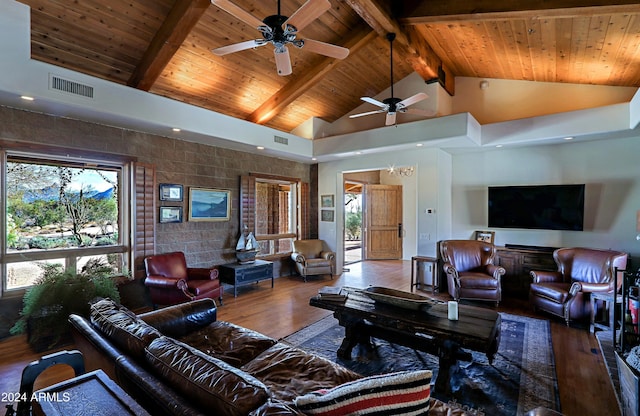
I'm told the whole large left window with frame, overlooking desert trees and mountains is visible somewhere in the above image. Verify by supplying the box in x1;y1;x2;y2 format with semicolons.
1;152;129;293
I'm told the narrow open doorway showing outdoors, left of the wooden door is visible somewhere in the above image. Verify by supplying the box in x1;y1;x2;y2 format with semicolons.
344;181;364;264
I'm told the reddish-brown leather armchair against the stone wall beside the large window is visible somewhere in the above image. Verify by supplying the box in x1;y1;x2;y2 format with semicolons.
144;251;223;307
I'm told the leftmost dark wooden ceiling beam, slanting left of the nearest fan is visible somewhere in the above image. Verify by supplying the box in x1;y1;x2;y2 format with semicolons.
127;0;211;91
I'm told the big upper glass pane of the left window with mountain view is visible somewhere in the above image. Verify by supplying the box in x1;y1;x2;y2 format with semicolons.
6;159;120;253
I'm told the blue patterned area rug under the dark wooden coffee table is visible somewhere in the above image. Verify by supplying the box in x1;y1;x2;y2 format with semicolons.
281;313;560;416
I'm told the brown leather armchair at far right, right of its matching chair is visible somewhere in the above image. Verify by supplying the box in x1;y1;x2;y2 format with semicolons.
529;247;627;325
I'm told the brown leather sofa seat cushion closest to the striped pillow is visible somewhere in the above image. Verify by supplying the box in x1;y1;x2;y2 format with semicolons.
241;343;361;402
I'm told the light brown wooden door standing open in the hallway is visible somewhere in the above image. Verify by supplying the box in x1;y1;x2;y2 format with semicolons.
364;185;402;260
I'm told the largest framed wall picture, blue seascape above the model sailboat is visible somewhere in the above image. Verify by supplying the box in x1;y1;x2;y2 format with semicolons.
189;188;231;221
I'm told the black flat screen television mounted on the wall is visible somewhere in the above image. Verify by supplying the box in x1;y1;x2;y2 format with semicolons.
488;185;585;231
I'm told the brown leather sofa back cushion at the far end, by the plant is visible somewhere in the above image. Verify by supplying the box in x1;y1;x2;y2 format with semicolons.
90;299;162;358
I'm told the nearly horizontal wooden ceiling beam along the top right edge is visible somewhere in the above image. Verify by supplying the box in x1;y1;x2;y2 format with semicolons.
398;0;640;25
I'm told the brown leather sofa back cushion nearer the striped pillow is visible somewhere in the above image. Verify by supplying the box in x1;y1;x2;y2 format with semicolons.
146;336;269;416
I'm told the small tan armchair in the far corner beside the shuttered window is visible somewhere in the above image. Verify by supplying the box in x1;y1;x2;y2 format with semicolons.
291;240;336;282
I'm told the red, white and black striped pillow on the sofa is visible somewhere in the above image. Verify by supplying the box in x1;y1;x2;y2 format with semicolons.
295;370;432;416
